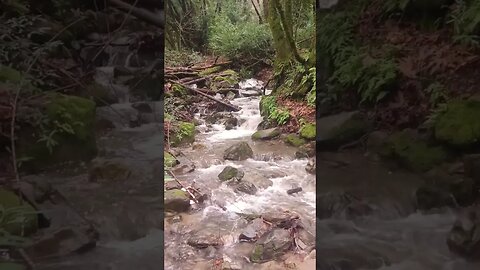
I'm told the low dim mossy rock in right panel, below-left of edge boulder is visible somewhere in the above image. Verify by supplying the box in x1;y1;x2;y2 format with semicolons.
379;130;448;172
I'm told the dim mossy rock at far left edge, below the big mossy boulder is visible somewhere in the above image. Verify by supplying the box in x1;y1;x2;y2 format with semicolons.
0;188;38;236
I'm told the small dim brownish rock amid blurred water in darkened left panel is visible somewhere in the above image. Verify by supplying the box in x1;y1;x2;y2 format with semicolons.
88;158;132;182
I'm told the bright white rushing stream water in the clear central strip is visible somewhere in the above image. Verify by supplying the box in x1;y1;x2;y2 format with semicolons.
165;79;315;270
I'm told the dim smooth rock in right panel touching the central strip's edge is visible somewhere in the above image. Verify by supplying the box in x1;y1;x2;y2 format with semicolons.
317;111;369;151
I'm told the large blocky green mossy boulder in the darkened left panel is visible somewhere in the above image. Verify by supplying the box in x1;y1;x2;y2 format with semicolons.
19;93;97;169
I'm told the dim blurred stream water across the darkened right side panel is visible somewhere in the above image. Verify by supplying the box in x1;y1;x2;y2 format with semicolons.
317;153;480;270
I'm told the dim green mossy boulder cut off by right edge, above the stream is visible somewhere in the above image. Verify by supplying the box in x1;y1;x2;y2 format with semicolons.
434;100;480;148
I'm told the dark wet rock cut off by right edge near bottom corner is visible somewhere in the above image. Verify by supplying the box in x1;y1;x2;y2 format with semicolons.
447;206;480;260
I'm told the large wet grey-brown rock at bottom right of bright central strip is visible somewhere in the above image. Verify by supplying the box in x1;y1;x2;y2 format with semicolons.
250;229;293;263
